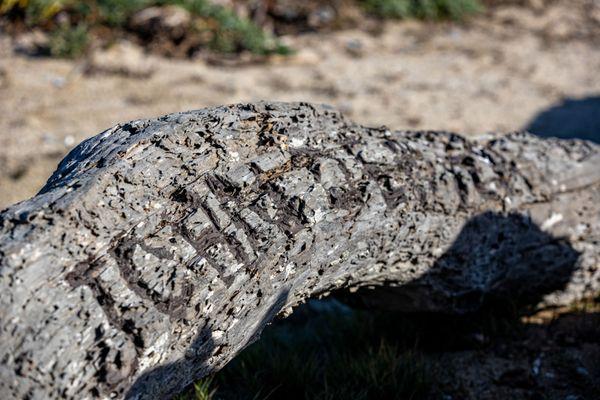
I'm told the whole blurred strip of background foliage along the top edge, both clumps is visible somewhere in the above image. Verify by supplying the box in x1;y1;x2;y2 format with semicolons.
0;0;483;58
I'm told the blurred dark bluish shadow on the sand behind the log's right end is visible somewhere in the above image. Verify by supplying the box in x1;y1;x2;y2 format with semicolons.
524;96;600;143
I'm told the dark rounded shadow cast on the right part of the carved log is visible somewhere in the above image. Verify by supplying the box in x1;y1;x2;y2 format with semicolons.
352;212;579;314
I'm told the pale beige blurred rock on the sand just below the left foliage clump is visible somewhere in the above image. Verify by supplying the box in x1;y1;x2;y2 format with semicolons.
86;41;155;78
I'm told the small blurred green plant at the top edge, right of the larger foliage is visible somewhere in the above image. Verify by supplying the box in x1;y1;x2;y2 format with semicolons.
361;0;483;20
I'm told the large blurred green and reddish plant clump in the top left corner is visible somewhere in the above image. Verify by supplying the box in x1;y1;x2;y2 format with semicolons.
0;0;291;57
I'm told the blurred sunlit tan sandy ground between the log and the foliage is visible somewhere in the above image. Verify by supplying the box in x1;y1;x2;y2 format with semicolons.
0;0;600;208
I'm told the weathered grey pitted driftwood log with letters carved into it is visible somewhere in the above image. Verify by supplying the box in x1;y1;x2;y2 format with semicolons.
0;103;600;399
